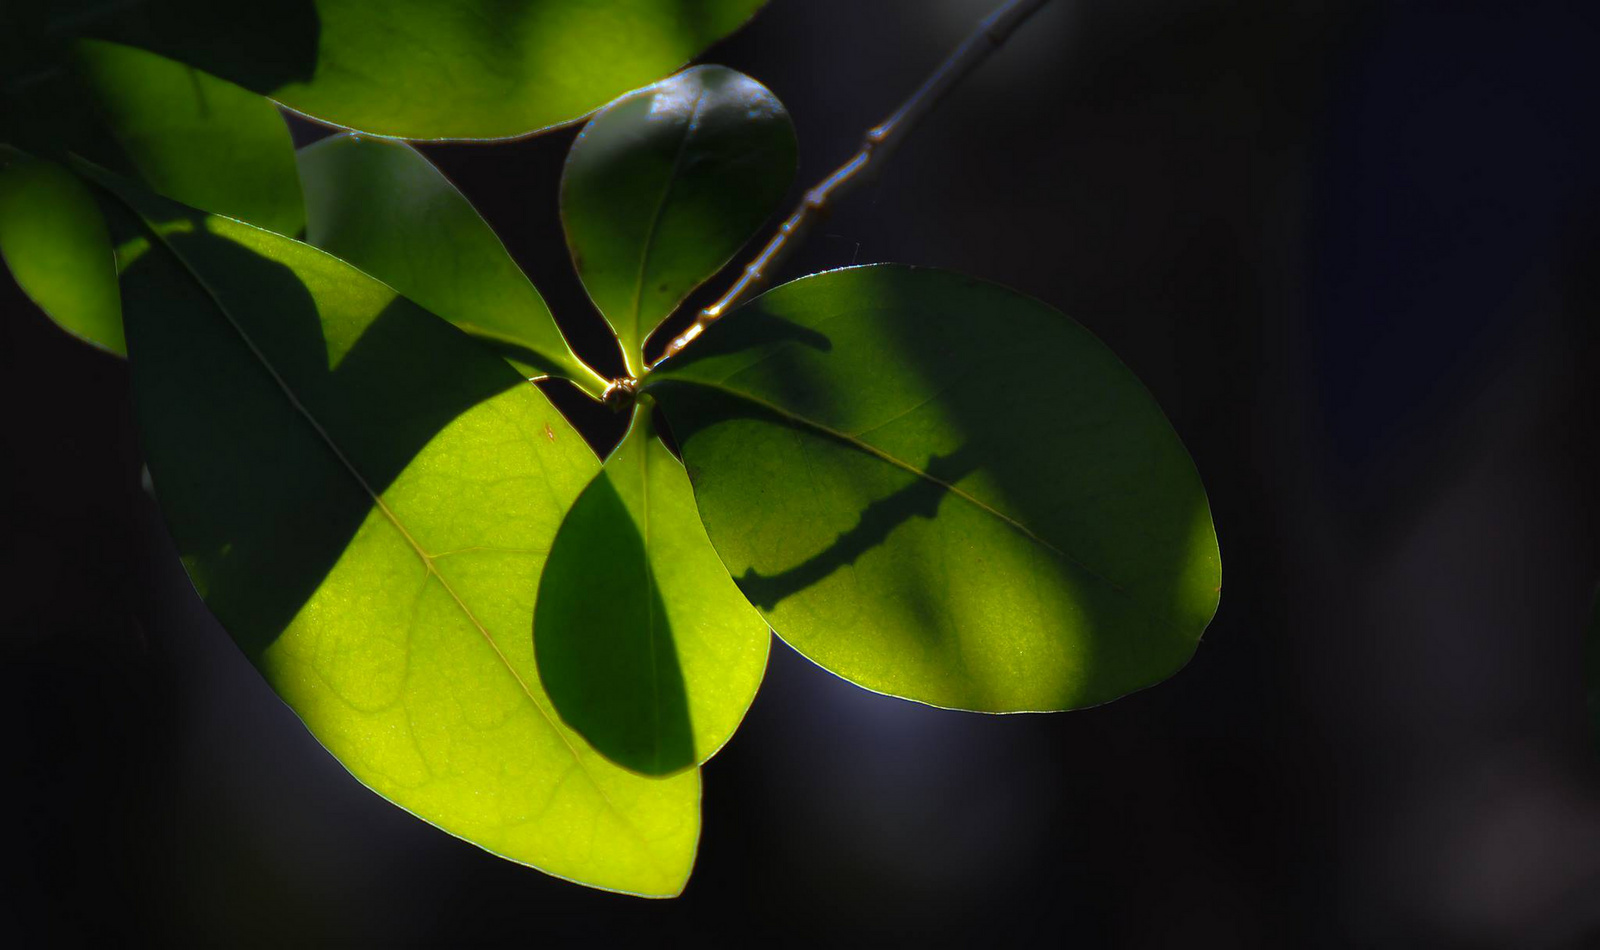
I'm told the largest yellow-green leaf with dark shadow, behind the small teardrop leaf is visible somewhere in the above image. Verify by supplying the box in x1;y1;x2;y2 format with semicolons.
96;171;699;896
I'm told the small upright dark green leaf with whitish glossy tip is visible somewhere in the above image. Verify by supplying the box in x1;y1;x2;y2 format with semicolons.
562;66;795;369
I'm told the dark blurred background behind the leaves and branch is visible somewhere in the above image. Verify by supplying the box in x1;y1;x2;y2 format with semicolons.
0;0;1600;947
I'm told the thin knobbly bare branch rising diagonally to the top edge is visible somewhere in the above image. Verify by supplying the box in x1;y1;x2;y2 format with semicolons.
656;0;1050;363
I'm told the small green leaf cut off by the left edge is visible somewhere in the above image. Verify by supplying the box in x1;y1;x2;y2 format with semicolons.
0;152;126;357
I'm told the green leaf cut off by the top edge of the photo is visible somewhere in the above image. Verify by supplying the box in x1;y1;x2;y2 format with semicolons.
48;0;763;139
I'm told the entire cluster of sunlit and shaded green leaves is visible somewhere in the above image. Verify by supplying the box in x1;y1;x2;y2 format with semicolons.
0;0;1219;896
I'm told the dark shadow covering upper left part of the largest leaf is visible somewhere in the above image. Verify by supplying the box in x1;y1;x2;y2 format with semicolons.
112;203;533;662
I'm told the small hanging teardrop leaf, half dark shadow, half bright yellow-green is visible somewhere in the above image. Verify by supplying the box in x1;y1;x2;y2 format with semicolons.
533;406;771;774
